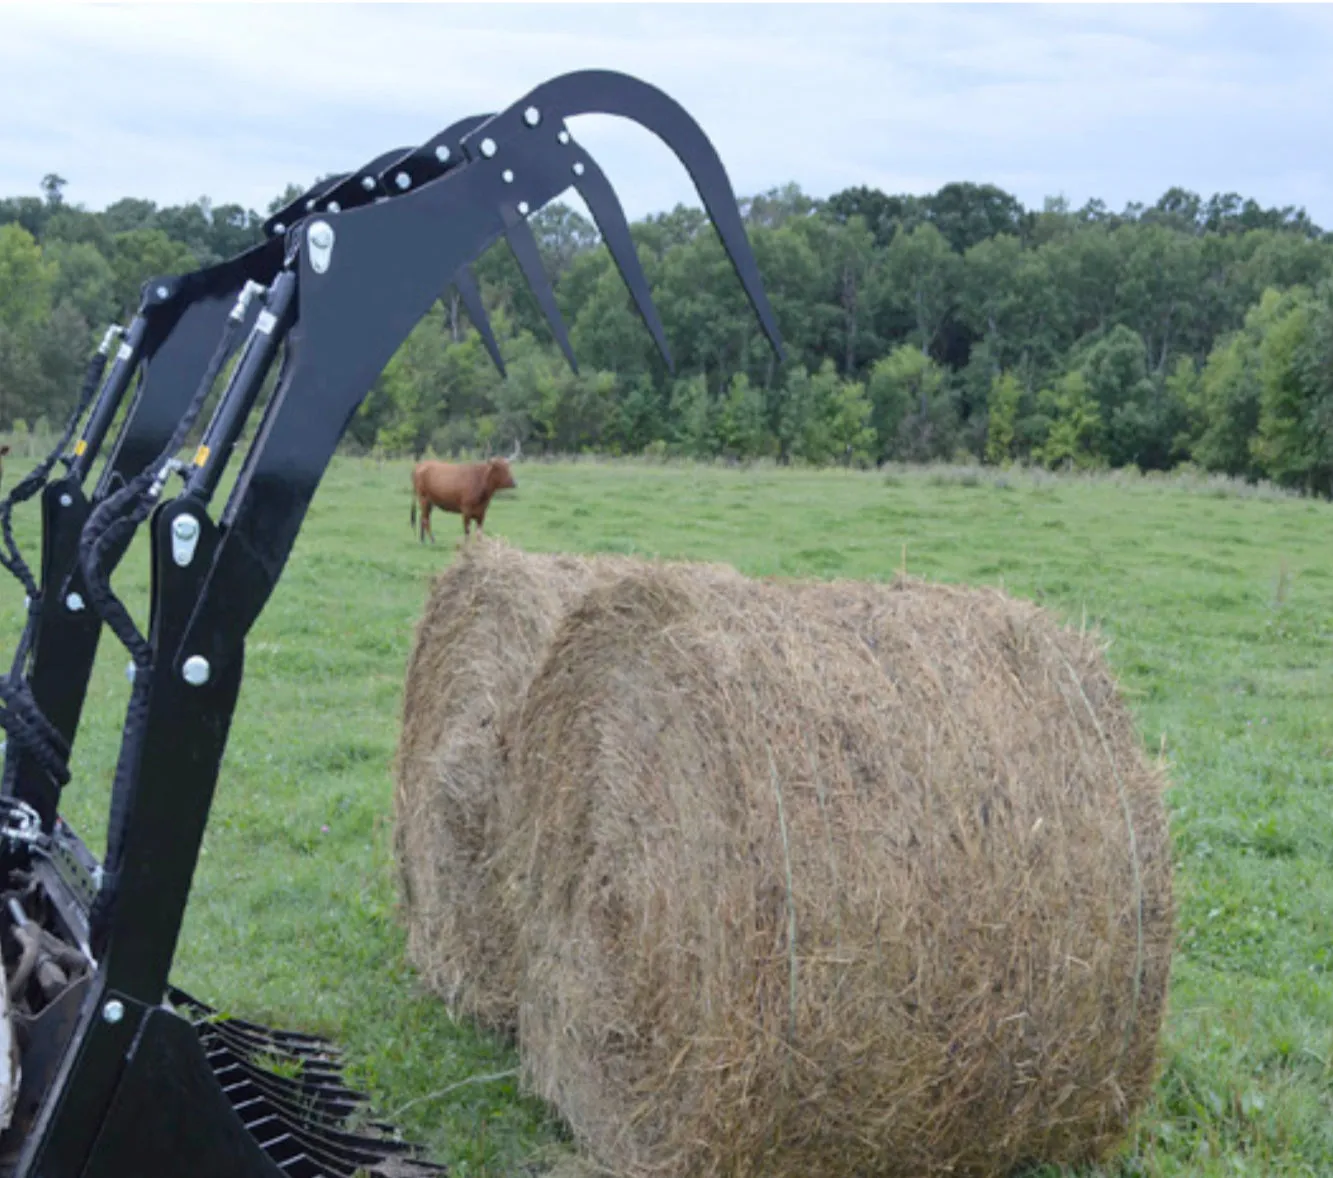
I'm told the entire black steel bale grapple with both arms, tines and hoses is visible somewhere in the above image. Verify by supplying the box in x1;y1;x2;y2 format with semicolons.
0;71;781;1178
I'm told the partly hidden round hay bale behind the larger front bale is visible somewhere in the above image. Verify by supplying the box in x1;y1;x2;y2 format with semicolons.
393;538;629;1030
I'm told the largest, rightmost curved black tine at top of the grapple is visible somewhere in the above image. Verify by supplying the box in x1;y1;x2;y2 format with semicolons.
463;69;785;360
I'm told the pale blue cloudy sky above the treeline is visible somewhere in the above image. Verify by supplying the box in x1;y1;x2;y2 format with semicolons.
0;0;1333;228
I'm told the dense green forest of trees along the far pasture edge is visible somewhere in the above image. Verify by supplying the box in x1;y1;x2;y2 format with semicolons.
0;175;1333;496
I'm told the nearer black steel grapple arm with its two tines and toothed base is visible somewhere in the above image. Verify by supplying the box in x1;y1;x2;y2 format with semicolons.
0;72;781;1178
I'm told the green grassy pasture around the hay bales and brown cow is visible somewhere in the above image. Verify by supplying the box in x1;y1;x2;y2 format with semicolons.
0;458;1333;1178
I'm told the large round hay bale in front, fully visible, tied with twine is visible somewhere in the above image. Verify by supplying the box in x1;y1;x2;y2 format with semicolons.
499;569;1172;1178
